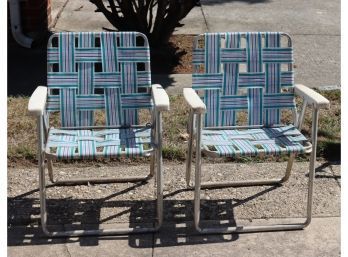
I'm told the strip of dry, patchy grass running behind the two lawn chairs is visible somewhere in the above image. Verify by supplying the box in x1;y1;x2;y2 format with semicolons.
7;90;341;166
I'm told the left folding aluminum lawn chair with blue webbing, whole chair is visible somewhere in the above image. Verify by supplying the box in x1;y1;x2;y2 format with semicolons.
28;32;169;236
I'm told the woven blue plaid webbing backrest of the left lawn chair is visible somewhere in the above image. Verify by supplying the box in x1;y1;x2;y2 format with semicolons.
47;32;152;127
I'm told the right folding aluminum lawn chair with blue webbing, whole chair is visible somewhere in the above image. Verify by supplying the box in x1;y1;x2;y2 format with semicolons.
184;32;329;233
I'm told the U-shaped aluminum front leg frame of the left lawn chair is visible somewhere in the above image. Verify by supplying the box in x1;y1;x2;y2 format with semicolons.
37;110;163;237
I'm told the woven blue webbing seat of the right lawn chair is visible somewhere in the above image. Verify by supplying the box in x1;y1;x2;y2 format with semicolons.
202;125;311;157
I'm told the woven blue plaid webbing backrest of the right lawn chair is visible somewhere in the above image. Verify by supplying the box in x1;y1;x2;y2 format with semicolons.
192;32;295;127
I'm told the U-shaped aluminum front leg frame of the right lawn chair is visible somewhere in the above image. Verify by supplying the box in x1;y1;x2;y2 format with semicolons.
194;109;319;234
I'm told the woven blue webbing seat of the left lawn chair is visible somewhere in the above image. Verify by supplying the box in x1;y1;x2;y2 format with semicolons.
46;127;154;160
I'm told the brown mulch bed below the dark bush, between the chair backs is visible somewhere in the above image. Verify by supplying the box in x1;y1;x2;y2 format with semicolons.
151;35;194;74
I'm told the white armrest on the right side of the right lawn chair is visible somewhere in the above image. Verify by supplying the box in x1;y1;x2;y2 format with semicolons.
295;84;330;109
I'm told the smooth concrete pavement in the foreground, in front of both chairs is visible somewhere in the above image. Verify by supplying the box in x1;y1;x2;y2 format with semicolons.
7;217;340;257
